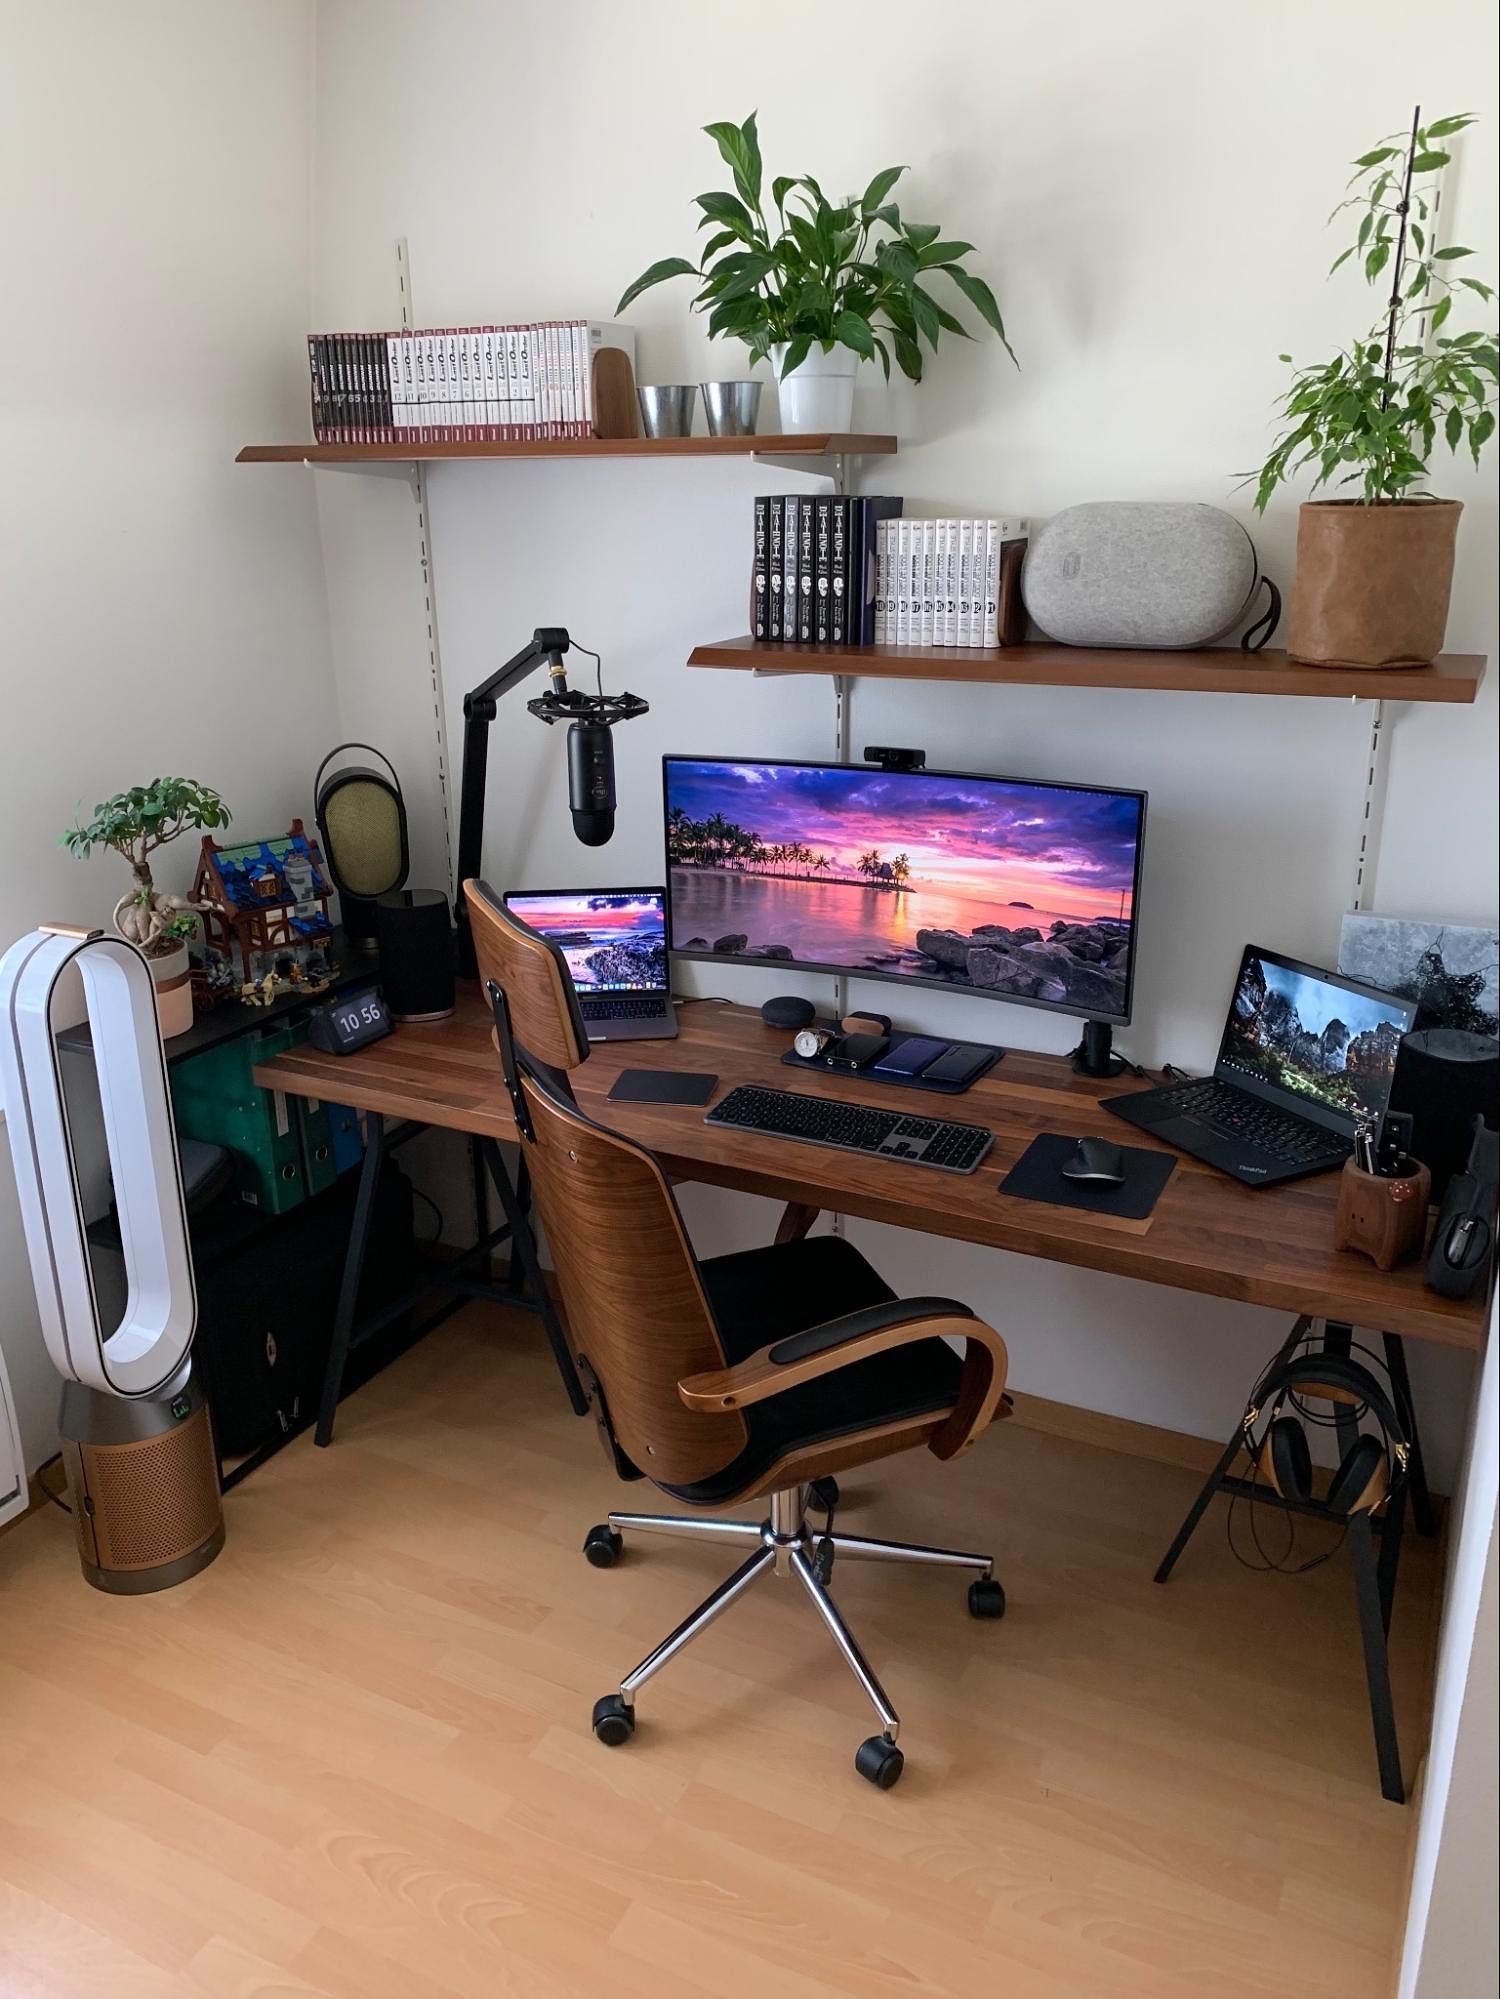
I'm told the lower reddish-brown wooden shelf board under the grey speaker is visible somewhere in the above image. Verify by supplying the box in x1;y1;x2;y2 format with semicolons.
688;636;1486;704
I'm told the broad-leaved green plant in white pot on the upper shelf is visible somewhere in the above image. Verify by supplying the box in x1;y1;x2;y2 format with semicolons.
616;112;1016;432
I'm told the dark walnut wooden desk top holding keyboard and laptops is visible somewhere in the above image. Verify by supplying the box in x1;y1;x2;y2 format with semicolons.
254;992;1486;1351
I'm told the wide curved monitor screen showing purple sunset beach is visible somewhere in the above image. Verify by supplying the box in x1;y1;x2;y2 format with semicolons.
662;756;1146;1021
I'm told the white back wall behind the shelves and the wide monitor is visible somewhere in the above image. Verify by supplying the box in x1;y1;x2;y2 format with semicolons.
312;0;1498;1477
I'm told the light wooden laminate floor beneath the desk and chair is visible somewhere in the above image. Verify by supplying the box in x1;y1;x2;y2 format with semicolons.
0;1305;1436;1999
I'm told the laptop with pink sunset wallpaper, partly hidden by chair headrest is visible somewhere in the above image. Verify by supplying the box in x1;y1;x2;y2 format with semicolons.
506;888;678;1041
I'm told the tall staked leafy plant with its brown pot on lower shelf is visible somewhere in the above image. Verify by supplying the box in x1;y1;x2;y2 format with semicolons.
1256;110;1500;666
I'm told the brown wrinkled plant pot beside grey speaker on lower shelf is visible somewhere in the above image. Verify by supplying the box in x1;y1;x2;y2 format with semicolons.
1286;500;1464;666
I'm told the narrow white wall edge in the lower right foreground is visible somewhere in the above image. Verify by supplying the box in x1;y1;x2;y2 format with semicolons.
1398;1313;1500;1999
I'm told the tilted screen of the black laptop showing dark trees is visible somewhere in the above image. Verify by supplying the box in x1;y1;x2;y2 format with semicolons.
1214;944;1416;1133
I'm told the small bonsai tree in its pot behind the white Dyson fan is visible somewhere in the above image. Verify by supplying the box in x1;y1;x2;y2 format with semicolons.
62;778;230;1039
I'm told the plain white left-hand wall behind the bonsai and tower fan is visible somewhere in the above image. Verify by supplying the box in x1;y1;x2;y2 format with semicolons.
0;0;334;1465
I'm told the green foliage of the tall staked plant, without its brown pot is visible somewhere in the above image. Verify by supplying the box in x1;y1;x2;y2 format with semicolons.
1256;108;1500;512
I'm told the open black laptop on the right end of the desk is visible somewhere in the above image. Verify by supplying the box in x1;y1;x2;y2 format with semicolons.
1106;944;1416;1187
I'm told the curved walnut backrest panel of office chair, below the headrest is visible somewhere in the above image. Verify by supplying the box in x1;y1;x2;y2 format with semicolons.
496;1015;746;1485
